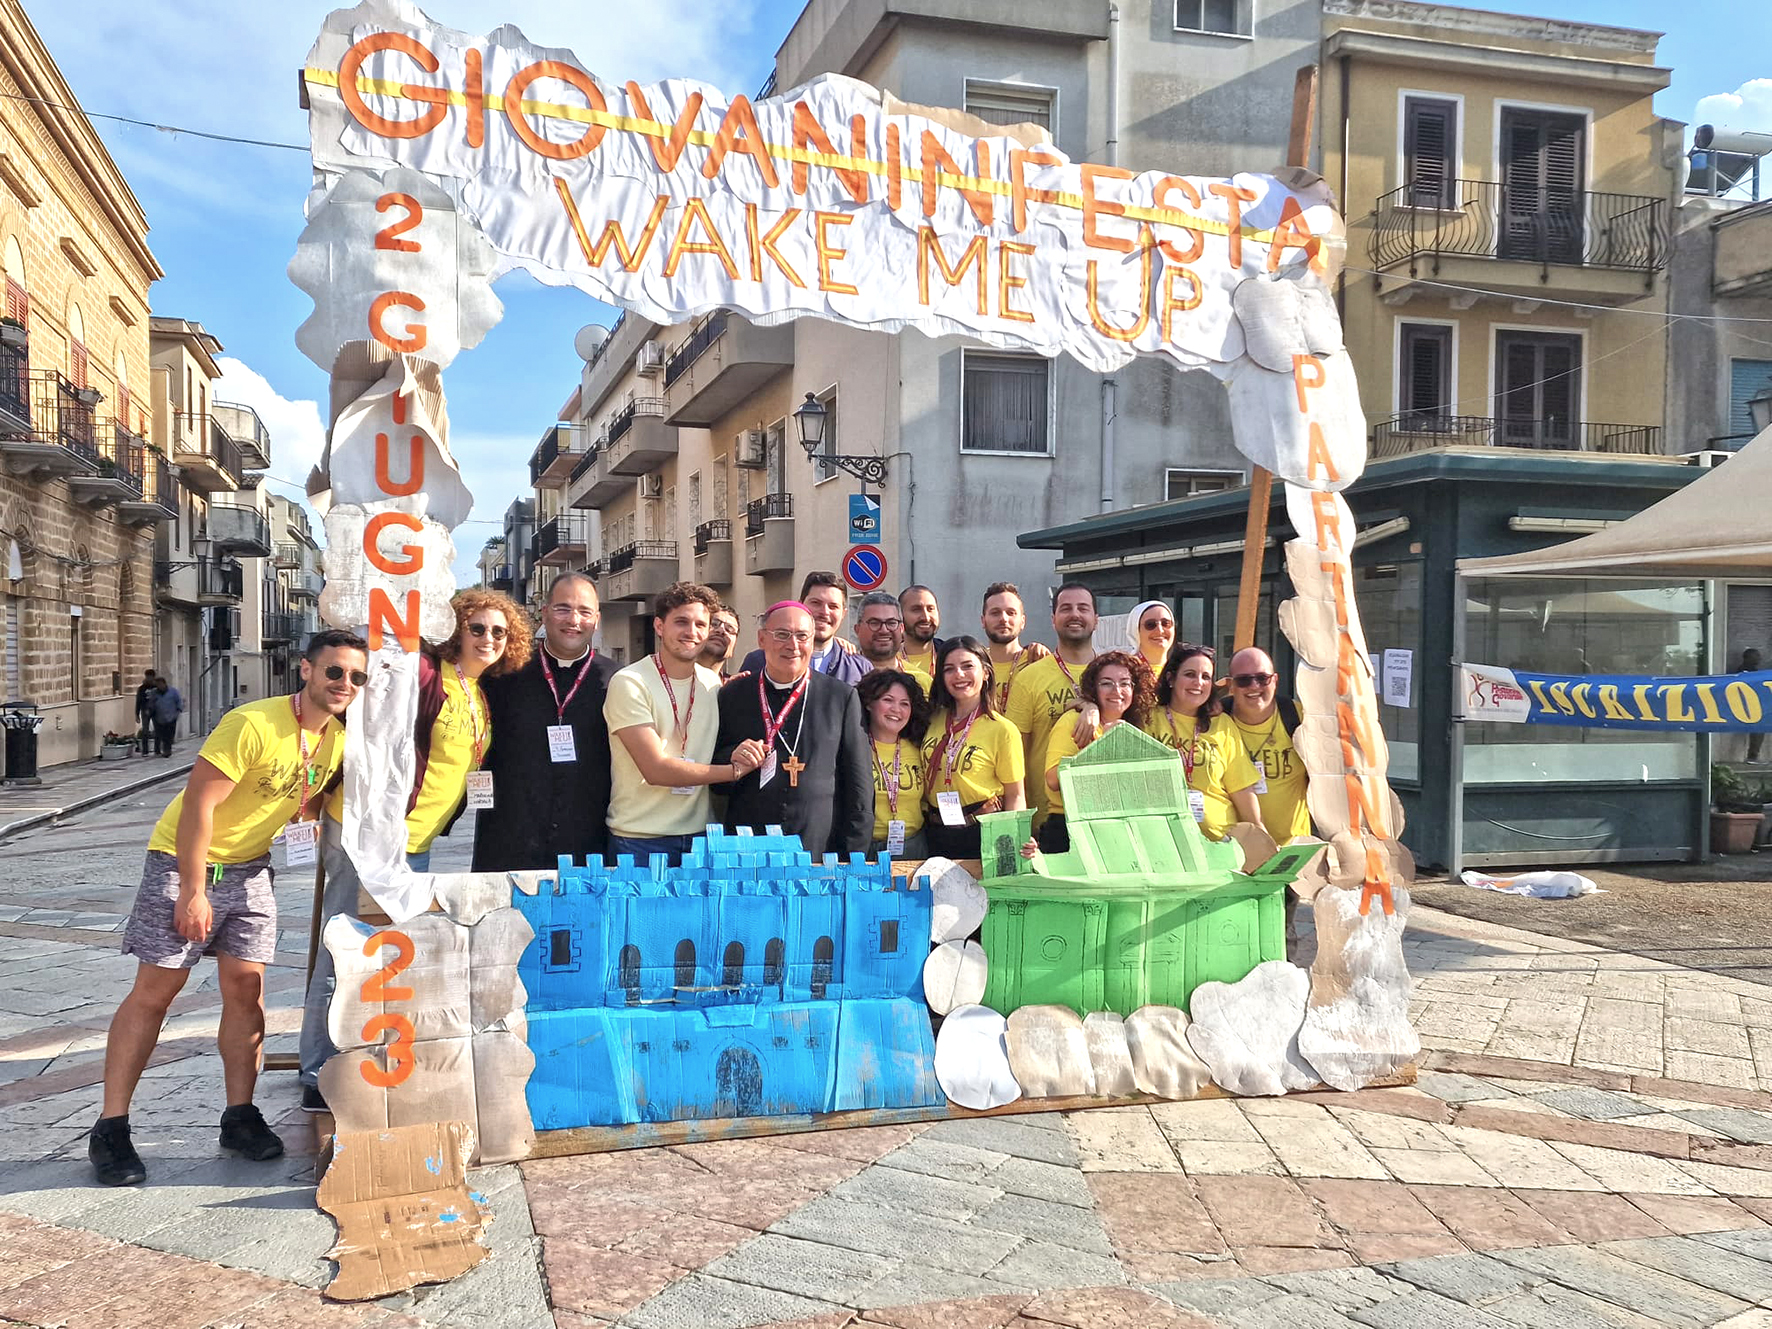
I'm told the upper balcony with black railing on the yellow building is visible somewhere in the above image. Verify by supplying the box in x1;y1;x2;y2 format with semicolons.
1372;177;1667;303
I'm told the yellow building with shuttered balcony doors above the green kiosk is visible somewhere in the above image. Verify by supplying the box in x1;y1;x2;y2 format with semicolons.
1320;0;1682;461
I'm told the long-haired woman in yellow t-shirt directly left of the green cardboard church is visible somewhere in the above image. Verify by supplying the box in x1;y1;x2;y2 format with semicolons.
923;636;1028;858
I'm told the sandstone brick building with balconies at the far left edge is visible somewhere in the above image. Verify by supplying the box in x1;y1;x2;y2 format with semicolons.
0;4;171;766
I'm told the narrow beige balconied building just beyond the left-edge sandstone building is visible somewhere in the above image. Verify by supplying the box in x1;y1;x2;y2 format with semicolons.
149;315;272;734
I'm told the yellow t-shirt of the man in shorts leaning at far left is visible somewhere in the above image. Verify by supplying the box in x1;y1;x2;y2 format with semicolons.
147;696;344;865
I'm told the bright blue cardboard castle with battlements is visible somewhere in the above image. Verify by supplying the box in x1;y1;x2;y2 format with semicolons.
512;826;943;1131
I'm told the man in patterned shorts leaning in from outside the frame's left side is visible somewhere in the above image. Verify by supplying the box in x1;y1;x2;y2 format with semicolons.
87;631;369;1185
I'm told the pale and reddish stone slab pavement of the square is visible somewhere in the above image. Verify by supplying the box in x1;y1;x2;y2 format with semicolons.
10;789;1772;1329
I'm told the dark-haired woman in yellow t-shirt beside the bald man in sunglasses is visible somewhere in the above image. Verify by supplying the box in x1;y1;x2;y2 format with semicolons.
1145;643;1262;840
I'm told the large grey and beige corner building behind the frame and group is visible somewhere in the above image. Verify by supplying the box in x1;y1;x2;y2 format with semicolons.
524;0;1320;659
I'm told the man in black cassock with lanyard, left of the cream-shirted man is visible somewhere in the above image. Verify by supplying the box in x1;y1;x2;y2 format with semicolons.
473;572;617;872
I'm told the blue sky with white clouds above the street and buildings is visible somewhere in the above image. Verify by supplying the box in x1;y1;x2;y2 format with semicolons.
25;0;1772;572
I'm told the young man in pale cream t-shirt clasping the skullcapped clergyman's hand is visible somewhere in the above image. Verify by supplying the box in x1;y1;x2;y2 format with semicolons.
602;581;764;863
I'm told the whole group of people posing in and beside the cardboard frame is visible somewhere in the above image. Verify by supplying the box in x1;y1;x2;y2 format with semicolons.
89;572;1310;1185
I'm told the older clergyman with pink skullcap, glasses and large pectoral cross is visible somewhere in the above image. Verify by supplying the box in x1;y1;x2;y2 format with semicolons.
714;601;874;858
